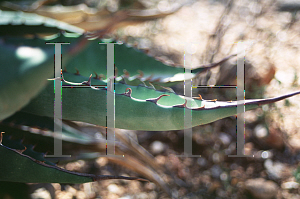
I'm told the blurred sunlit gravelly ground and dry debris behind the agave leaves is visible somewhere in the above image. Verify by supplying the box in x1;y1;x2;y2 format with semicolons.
0;0;300;199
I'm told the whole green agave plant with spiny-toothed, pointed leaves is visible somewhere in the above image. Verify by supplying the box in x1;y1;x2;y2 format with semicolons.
0;6;300;197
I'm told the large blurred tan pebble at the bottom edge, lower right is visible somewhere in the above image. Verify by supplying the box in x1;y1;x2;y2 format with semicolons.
245;178;279;199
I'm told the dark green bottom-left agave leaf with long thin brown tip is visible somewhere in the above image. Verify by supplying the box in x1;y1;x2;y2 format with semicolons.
0;133;147;184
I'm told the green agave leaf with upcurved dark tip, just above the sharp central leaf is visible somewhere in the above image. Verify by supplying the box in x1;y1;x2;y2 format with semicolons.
65;37;235;86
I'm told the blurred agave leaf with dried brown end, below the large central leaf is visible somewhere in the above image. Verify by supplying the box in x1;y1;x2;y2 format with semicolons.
0;112;170;193
